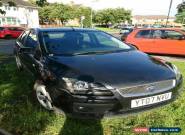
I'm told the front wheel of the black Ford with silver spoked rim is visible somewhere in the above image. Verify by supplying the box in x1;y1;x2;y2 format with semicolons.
34;80;54;111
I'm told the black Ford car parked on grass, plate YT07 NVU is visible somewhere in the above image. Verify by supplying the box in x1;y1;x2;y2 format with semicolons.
14;28;183;118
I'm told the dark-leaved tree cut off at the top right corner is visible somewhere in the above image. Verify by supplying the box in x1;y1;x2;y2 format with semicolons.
176;2;185;23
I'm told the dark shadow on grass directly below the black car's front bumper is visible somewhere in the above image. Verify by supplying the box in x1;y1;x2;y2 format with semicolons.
59;117;103;135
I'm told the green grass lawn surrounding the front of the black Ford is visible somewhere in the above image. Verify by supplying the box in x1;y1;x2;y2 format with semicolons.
0;56;185;135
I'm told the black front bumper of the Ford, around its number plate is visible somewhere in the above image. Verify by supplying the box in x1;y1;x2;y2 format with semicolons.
55;77;183;118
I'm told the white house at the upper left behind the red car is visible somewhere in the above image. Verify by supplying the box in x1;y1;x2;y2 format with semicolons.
0;0;39;27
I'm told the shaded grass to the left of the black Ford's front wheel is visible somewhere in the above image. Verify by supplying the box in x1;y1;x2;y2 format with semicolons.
0;55;56;135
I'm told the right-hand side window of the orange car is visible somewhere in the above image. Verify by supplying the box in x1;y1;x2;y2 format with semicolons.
163;30;183;40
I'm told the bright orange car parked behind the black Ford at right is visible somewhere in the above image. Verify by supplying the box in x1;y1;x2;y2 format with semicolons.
125;28;185;56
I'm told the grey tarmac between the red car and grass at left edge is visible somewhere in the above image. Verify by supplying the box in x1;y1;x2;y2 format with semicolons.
0;39;15;54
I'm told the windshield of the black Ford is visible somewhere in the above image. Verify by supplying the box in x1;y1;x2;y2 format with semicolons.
42;31;131;55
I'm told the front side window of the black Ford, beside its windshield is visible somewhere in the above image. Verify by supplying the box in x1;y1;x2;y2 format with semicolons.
25;30;37;48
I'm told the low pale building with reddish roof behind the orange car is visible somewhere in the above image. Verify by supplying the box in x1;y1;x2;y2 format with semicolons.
132;15;179;25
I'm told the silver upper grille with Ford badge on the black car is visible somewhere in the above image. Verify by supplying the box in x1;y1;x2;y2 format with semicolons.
119;80;176;97
